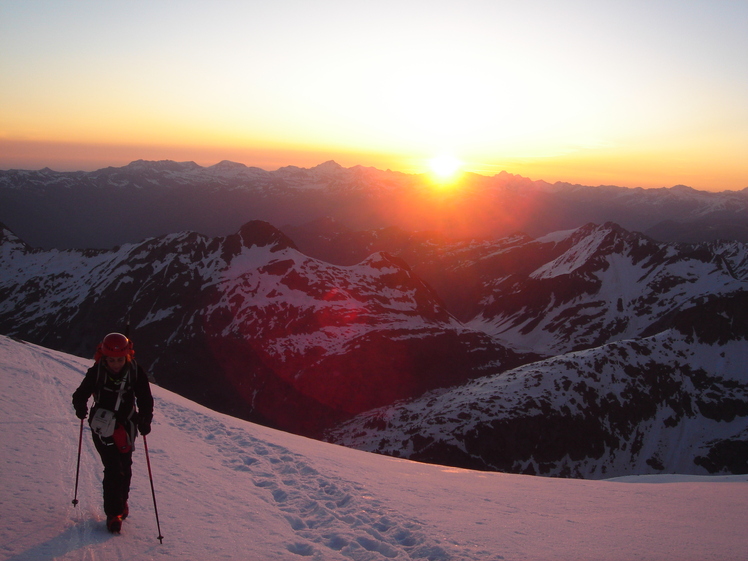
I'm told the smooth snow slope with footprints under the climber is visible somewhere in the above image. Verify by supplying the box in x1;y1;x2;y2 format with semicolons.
0;336;748;561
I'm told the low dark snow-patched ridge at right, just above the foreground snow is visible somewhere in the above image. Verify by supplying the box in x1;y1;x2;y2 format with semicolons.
327;316;748;478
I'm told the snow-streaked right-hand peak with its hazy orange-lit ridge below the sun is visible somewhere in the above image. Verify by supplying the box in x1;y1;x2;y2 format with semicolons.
286;221;748;334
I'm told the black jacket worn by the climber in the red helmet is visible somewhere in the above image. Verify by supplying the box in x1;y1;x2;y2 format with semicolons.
73;360;153;438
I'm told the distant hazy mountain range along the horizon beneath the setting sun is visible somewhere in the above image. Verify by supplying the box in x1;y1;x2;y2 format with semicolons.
0;160;748;247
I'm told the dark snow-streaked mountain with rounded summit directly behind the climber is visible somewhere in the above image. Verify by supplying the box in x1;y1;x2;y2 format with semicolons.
0;222;537;435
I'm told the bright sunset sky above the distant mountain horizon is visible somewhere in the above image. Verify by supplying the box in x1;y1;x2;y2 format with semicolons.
0;0;748;191
